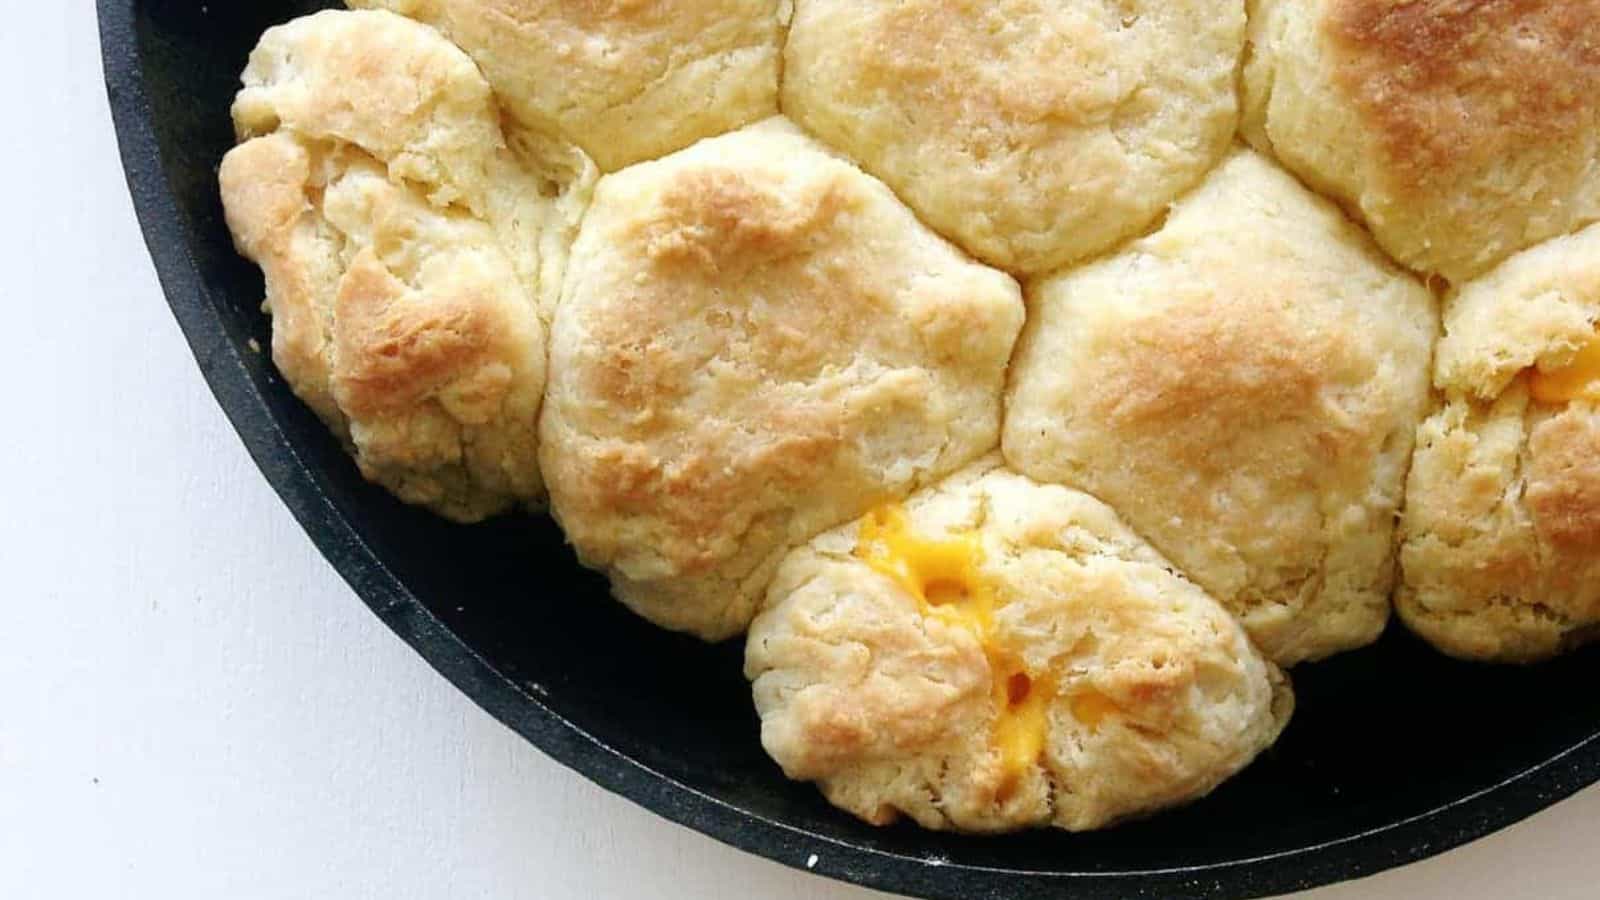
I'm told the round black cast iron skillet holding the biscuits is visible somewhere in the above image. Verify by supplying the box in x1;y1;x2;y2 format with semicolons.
98;0;1600;900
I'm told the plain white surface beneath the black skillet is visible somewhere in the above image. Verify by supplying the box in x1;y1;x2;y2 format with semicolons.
0;7;1600;900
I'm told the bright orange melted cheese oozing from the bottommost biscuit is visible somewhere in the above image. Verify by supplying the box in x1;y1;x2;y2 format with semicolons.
856;506;1056;786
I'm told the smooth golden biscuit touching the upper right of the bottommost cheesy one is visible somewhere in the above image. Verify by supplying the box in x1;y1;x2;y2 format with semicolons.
1003;151;1438;665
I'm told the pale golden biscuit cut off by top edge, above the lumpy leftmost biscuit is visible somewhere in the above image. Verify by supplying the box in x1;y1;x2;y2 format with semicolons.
349;0;782;171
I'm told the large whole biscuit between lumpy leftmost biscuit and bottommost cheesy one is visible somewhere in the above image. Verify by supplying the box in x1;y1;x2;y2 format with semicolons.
541;119;1022;639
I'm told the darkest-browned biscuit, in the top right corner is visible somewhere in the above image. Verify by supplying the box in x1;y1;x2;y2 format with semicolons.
1245;0;1600;282
